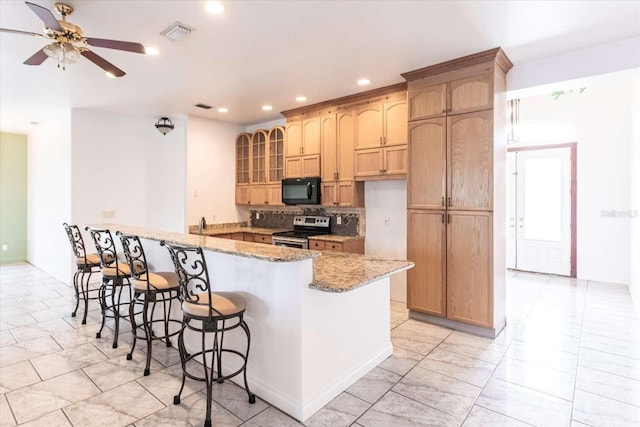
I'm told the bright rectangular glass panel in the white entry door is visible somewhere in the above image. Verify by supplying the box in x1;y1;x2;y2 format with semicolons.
524;158;562;242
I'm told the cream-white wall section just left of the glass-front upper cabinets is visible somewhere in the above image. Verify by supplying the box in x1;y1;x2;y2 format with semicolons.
187;116;248;225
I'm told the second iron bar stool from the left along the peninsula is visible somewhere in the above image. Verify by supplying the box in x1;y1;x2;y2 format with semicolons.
85;227;141;348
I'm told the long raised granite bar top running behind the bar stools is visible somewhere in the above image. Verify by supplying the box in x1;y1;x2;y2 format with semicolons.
90;224;320;262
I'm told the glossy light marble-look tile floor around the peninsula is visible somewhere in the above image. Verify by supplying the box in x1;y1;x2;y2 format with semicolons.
0;264;640;427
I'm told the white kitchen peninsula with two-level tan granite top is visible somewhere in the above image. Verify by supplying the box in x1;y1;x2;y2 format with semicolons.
92;224;413;421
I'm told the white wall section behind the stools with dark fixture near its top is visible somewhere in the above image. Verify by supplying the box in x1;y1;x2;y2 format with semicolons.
71;109;186;232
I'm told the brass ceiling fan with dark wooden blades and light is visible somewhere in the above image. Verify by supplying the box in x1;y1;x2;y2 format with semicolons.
0;2;145;77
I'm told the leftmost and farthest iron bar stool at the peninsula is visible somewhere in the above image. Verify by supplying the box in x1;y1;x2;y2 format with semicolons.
62;226;100;325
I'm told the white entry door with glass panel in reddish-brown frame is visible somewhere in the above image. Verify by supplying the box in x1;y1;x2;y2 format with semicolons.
507;142;577;277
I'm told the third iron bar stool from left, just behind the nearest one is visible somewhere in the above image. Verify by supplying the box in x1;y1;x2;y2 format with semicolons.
116;231;182;376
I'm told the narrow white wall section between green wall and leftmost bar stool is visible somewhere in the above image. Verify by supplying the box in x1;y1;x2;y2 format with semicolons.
27;110;72;283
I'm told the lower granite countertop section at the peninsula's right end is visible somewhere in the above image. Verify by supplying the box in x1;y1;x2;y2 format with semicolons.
309;251;415;292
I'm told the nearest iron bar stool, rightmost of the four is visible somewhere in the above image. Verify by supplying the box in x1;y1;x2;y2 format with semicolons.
160;241;256;427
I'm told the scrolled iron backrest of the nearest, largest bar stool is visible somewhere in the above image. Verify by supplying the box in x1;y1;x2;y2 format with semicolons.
160;241;222;317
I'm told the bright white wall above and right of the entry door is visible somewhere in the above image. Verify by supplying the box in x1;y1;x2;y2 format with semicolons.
520;80;632;283
